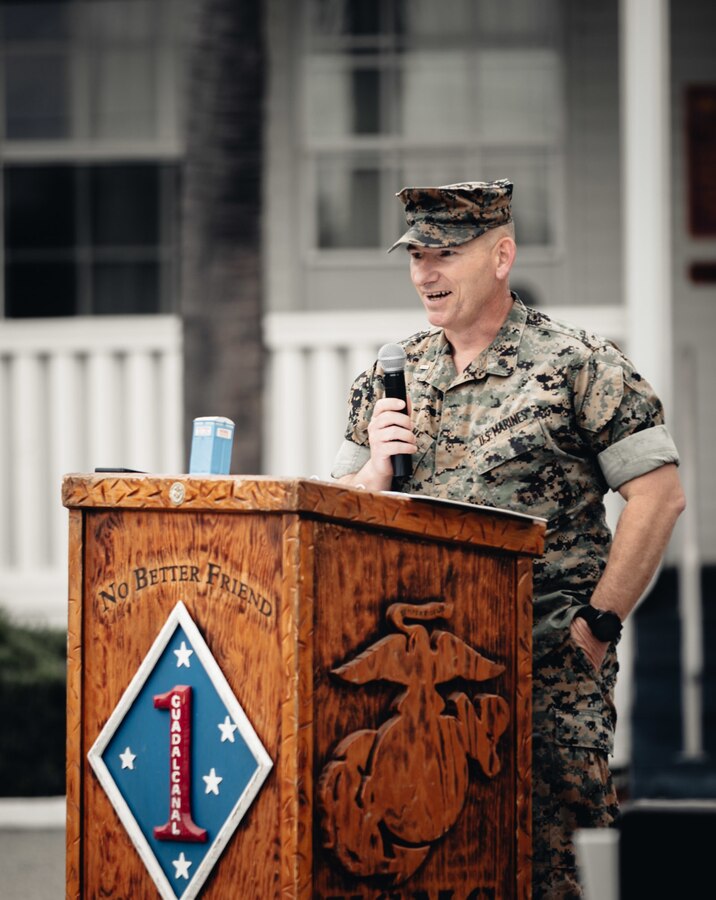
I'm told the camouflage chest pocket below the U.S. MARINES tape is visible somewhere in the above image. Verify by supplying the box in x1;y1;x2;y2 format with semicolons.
473;422;573;519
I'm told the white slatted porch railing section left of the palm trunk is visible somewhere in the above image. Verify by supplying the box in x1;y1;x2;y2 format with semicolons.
0;316;185;625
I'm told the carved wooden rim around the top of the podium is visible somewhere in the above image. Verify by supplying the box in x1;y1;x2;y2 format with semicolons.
62;473;546;556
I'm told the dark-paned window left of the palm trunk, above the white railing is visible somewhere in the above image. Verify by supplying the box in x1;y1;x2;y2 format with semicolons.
0;0;184;318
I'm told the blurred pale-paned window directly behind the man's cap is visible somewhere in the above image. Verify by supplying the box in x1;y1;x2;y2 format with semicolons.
300;0;564;261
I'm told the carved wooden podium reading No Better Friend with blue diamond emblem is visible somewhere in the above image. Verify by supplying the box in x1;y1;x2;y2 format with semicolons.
63;474;544;900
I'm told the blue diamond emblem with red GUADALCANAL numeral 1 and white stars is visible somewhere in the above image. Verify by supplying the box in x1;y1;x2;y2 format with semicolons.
88;603;273;900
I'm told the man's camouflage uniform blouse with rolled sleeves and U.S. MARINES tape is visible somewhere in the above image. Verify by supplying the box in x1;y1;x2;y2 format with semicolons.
332;295;678;659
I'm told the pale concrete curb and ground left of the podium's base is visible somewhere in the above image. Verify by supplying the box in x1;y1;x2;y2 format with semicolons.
0;797;65;900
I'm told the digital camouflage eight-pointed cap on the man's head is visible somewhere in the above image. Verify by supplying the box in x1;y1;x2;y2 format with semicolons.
388;178;512;253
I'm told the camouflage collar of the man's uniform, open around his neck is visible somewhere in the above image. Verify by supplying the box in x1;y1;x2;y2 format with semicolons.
417;291;527;391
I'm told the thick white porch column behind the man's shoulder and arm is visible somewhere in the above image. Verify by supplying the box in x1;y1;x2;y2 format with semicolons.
615;0;673;764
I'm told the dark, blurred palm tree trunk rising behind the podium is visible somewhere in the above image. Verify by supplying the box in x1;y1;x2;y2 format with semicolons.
181;0;266;474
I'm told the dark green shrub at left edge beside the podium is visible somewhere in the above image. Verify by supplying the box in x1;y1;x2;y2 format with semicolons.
0;610;67;797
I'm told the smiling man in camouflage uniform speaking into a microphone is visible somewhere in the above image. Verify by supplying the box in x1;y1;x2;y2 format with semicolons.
333;180;684;900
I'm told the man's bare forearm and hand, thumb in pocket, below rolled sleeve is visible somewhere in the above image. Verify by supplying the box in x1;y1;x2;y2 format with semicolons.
571;464;686;669
